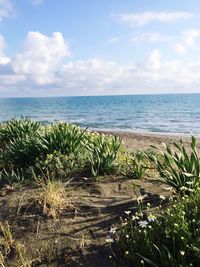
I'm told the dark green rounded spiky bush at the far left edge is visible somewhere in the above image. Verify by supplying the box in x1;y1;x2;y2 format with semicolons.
0;119;43;168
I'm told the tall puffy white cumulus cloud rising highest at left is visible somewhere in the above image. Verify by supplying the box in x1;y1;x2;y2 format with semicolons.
12;32;70;84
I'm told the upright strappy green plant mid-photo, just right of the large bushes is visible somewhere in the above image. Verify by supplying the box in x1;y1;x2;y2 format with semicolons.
88;134;121;177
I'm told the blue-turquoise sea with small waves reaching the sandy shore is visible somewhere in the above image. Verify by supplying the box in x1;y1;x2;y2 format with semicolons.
0;94;200;135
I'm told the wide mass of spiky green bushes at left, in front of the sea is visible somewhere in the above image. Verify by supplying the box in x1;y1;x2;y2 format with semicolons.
0;119;87;172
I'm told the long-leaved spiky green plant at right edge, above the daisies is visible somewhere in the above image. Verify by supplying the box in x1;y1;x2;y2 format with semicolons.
149;136;200;195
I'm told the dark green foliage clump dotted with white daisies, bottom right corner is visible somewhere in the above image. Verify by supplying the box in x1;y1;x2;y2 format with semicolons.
108;189;200;267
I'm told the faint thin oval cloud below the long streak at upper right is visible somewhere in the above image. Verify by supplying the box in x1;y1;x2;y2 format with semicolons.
131;32;172;45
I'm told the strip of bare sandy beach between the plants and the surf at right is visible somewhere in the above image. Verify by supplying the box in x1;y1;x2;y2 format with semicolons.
98;131;197;150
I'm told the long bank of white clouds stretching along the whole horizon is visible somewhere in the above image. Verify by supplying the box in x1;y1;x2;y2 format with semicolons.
0;32;200;96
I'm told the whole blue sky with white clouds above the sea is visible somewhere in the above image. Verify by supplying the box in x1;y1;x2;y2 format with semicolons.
0;0;200;97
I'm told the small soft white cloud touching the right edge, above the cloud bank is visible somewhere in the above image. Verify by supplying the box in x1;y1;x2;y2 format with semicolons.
175;29;200;54
